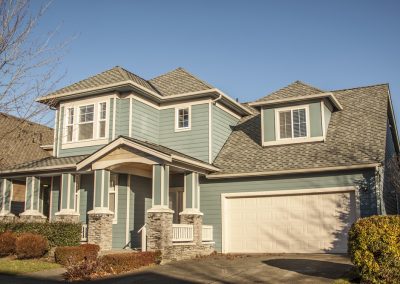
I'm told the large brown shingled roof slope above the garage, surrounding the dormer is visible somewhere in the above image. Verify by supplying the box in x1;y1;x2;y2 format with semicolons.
214;82;389;175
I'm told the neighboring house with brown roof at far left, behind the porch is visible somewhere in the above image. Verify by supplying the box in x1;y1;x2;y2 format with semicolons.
0;113;54;215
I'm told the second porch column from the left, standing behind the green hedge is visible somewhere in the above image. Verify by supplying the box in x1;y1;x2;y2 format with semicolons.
19;176;47;222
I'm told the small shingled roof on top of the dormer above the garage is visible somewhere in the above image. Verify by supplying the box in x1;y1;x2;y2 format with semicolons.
255;81;325;102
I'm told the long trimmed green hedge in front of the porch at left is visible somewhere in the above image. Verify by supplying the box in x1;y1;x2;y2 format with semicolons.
0;222;82;247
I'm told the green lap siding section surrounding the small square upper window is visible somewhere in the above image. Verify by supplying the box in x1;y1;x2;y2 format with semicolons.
159;104;209;162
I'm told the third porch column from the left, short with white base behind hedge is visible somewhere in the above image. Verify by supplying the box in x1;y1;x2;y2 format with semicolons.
54;173;79;223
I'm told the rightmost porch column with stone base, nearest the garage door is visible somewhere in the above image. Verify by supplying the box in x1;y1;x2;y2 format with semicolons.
179;172;203;245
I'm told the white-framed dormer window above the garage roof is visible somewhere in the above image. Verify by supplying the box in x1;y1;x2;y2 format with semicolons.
278;108;308;139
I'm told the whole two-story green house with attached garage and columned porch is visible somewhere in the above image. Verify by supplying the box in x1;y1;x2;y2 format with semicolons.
0;66;399;258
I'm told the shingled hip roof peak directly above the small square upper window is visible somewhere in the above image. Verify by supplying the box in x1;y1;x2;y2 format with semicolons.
149;67;214;96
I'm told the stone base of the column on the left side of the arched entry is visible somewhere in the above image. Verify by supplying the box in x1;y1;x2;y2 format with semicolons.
88;209;114;251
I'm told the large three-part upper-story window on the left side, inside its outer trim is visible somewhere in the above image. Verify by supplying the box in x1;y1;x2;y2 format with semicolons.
64;102;108;142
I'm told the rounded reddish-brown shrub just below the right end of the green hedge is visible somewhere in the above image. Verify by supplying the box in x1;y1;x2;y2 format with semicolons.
54;244;100;265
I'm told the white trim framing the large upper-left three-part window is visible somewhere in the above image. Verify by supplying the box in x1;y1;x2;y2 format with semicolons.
62;98;110;145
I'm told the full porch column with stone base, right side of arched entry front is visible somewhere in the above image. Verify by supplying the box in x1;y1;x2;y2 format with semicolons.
146;165;174;251
